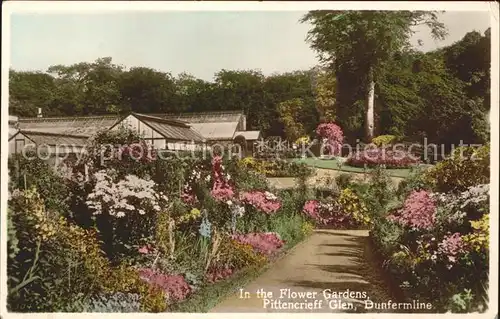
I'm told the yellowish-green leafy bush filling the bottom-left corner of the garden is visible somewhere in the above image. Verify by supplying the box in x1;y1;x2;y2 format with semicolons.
8;189;107;311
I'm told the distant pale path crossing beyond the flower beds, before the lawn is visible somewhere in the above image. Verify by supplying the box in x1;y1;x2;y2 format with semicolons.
267;168;404;189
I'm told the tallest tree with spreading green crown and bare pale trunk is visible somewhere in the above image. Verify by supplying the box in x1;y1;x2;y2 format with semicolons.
301;11;446;141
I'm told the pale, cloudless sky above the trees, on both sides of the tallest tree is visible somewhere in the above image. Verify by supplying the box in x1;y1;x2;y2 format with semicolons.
10;11;490;81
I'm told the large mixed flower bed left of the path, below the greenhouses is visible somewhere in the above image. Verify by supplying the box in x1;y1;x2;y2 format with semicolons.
8;127;310;312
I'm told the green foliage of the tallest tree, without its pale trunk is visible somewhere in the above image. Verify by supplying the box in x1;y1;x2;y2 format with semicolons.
302;10;446;141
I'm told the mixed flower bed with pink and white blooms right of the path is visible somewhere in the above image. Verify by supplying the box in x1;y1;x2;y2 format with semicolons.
371;146;489;312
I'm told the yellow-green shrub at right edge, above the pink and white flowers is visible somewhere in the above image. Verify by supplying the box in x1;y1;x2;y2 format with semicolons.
425;145;490;192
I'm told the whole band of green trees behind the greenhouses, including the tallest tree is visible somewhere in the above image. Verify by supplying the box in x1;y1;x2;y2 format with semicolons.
9;16;491;147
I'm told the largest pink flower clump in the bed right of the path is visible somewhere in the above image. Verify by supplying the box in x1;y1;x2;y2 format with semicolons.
388;190;436;229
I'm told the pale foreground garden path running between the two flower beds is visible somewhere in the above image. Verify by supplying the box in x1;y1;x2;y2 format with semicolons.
210;230;391;313
